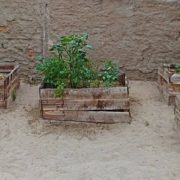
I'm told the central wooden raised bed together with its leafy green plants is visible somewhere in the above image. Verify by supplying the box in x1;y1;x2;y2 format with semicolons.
37;34;131;123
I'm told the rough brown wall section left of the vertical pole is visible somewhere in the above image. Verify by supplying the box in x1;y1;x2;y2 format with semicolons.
0;0;42;77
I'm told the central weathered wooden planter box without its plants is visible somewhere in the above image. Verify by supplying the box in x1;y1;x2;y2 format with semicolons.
39;76;131;123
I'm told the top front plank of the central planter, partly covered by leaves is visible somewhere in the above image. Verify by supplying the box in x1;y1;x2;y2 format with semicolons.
40;87;128;99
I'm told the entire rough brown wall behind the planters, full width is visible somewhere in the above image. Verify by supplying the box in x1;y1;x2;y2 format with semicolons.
0;0;180;79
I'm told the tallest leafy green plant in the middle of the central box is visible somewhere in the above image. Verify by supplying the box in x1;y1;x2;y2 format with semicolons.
48;34;94;88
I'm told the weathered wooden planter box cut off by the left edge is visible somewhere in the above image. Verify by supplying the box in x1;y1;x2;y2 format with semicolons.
0;65;20;108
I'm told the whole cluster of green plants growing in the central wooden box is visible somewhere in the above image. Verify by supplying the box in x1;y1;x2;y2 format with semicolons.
36;34;119;97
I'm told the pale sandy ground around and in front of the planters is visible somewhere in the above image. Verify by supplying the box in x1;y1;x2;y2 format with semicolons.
0;81;180;180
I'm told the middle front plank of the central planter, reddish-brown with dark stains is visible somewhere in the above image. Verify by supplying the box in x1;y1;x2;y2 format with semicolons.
41;98;130;111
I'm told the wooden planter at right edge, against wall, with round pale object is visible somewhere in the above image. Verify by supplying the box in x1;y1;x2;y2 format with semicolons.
158;65;180;105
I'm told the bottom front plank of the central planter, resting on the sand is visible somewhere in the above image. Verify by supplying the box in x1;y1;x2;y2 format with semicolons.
42;111;131;123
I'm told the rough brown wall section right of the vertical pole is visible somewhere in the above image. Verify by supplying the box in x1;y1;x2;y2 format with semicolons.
49;0;180;77
